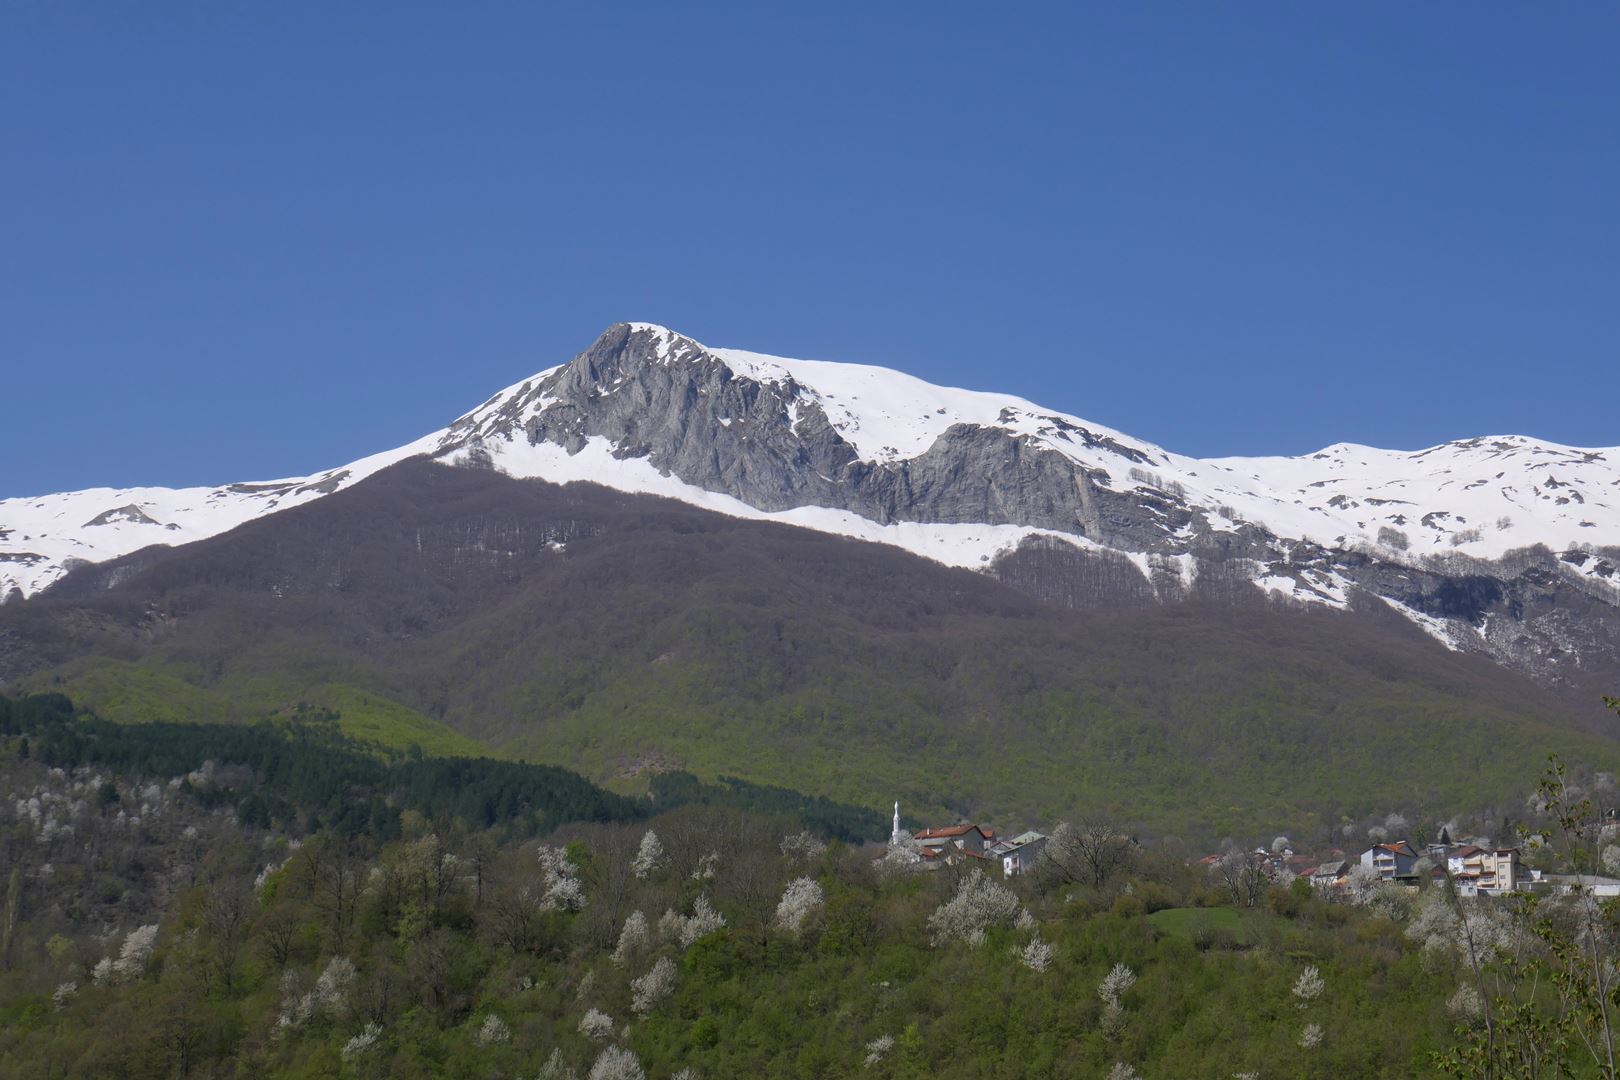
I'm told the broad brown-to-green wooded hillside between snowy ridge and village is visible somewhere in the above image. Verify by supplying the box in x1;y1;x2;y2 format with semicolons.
0;461;1620;834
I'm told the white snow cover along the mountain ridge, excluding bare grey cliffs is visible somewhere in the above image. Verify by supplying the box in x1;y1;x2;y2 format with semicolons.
0;324;1620;604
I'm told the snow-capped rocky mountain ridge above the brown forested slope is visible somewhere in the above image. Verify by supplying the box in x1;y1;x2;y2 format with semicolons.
0;324;1620;680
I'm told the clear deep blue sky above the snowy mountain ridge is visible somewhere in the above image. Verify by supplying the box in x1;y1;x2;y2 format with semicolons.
0;0;1620;495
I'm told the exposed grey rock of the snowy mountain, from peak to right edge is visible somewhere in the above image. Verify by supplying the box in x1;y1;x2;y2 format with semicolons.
441;324;1620;687
